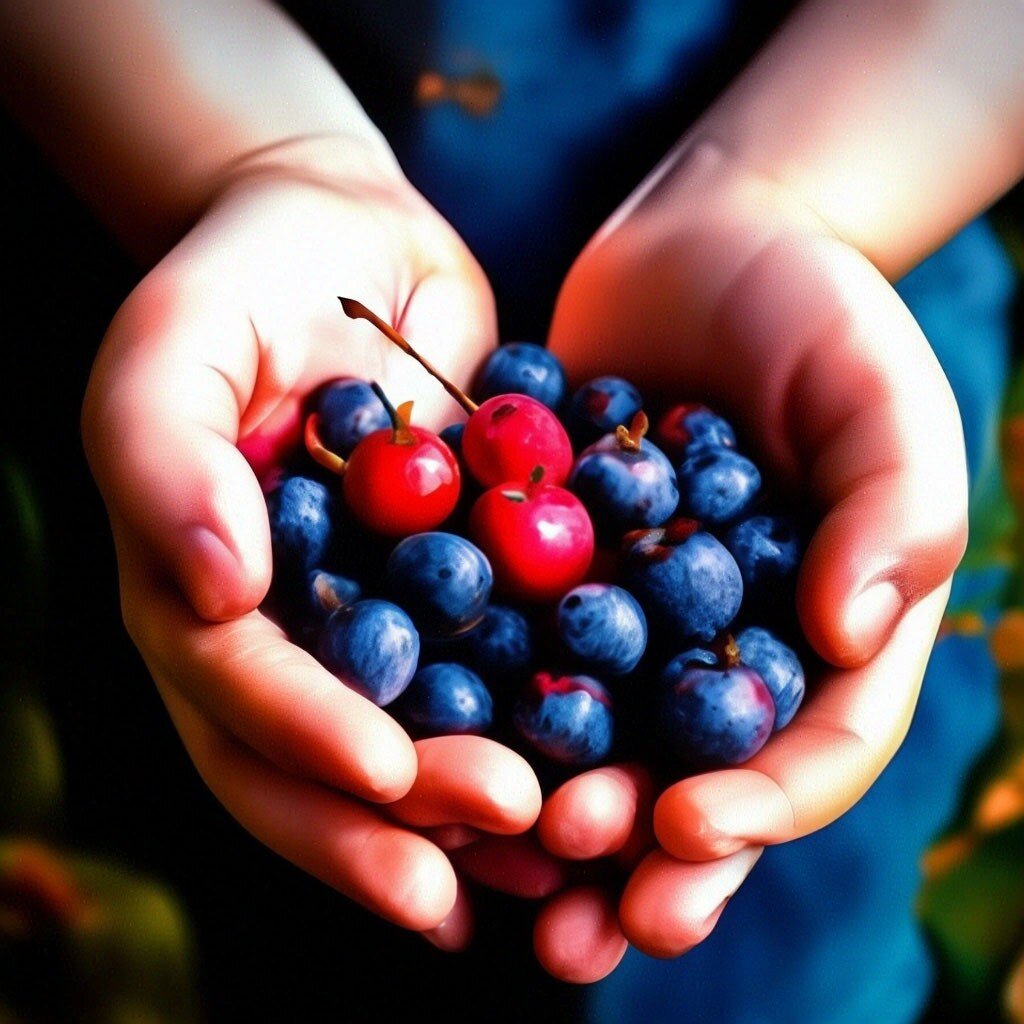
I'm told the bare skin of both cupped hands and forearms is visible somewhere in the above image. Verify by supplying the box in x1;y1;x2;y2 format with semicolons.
0;0;1024;981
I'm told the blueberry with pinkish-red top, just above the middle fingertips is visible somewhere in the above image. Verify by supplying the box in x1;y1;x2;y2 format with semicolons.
513;672;614;765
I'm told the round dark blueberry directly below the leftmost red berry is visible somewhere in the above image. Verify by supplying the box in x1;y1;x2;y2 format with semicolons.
384;532;494;637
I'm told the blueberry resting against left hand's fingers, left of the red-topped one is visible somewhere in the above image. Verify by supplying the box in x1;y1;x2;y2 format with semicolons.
391;662;494;736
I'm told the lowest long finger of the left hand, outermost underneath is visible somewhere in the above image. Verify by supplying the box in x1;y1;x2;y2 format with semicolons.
157;679;457;931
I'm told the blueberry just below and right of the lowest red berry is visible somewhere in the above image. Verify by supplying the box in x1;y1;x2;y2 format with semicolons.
558;583;647;676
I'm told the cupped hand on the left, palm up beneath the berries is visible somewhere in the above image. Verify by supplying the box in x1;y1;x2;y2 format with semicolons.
83;159;540;930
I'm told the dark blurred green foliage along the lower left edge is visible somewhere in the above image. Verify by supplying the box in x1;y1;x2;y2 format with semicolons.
0;454;200;1024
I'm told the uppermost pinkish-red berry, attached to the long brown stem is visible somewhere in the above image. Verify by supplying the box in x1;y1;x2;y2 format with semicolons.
462;394;572;487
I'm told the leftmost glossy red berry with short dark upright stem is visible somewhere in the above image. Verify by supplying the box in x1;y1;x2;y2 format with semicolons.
342;427;460;537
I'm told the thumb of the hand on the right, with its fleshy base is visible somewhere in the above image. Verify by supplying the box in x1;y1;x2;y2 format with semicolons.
722;240;968;667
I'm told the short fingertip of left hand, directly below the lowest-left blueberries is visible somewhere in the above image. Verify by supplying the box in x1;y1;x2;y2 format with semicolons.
388;736;542;836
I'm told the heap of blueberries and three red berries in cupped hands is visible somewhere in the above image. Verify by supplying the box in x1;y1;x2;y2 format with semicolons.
260;300;805;778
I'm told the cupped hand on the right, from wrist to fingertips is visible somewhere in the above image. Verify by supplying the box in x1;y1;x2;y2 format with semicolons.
528;147;967;974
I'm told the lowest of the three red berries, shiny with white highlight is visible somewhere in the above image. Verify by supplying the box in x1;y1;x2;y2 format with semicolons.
469;470;594;601
